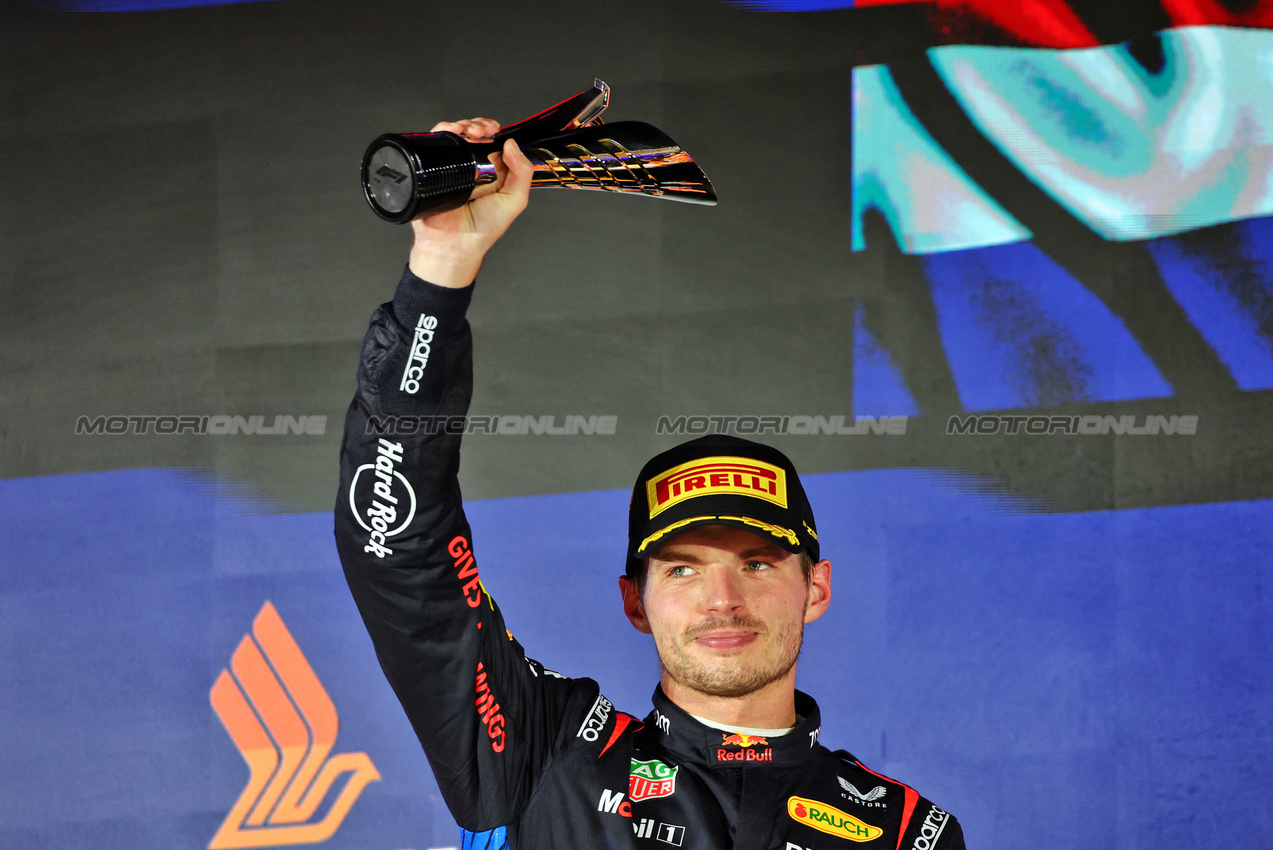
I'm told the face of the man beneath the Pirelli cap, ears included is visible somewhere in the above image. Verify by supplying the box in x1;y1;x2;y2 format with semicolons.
620;526;831;697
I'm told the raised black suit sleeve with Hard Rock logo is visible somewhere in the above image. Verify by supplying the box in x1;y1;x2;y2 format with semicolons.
335;271;597;830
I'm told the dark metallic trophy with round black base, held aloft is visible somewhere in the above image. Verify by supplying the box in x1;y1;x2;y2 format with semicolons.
363;80;717;224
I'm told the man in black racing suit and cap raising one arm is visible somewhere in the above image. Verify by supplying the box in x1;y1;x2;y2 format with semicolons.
336;118;964;850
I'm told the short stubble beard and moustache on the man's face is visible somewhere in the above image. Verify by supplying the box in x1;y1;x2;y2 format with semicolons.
656;617;805;697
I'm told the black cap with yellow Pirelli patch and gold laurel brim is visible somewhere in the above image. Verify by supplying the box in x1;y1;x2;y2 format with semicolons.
628;434;819;575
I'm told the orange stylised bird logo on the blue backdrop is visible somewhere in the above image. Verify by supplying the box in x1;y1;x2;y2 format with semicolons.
207;602;381;850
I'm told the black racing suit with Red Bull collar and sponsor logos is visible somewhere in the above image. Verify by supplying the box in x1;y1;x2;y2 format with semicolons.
336;272;964;850
